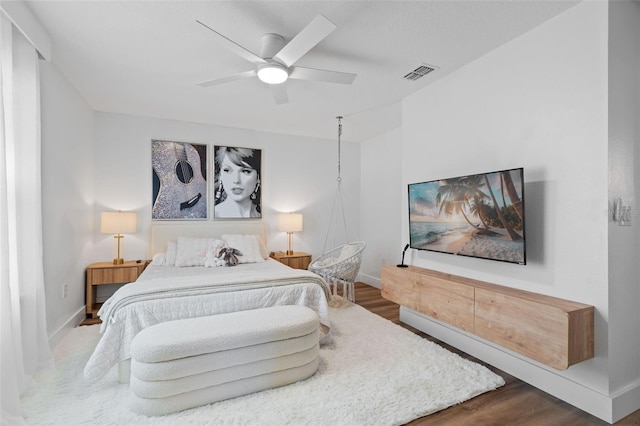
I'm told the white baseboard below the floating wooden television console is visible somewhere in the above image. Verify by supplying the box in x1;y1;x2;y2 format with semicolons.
400;306;640;423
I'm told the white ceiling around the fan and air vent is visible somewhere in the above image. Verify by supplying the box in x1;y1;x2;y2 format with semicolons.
26;0;576;141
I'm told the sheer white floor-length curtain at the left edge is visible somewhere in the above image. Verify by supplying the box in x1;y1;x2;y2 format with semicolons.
0;12;51;425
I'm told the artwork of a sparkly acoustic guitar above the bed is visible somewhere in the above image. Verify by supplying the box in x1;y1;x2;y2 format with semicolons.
151;140;207;220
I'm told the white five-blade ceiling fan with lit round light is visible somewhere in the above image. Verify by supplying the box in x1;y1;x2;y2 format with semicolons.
196;15;356;105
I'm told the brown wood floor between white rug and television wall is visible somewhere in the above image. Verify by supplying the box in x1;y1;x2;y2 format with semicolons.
356;283;640;426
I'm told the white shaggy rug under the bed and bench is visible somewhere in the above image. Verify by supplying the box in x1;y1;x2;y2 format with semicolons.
21;302;504;426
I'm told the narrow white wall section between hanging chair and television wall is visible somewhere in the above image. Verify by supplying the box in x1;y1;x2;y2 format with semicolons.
359;128;408;287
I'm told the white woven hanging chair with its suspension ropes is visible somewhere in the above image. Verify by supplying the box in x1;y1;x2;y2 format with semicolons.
308;116;366;302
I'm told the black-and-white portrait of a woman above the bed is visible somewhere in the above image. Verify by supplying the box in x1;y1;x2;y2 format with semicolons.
213;146;262;219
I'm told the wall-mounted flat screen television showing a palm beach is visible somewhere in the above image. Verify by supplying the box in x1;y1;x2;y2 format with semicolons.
408;168;527;265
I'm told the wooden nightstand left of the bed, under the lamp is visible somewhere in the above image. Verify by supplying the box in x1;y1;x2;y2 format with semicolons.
83;260;149;324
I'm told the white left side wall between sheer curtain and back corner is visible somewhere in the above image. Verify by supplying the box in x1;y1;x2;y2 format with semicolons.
40;61;94;343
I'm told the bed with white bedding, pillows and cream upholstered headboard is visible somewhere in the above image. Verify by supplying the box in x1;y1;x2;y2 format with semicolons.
84;221;331;381
